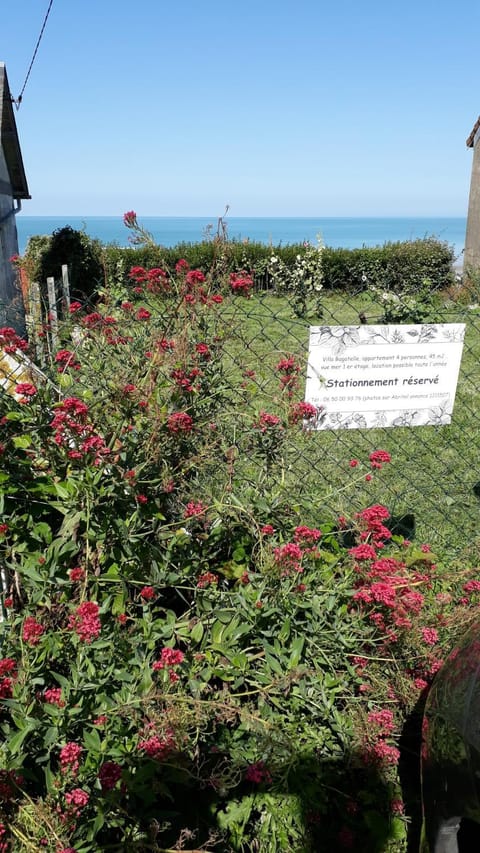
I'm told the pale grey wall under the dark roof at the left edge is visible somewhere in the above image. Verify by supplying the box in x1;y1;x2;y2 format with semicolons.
0;148;24;333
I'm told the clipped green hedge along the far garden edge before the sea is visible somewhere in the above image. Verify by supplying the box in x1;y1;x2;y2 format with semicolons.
22;228;454;302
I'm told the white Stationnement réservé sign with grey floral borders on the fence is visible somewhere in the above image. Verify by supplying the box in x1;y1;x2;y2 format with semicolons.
305;323;465;429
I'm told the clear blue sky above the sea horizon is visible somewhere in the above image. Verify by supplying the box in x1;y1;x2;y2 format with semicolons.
0;0;480;216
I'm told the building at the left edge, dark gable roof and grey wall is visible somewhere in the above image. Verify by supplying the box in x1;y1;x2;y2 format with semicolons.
0;62;30;334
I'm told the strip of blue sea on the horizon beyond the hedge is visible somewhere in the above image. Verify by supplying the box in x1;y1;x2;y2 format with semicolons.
17;214;466;257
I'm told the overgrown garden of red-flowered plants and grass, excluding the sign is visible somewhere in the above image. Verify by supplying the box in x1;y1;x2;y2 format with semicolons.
0;212;480;853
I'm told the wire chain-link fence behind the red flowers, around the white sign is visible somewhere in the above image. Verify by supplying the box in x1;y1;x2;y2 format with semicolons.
3;270;480;556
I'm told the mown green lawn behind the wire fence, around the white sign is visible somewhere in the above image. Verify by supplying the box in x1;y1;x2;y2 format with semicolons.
219;293;480;558
